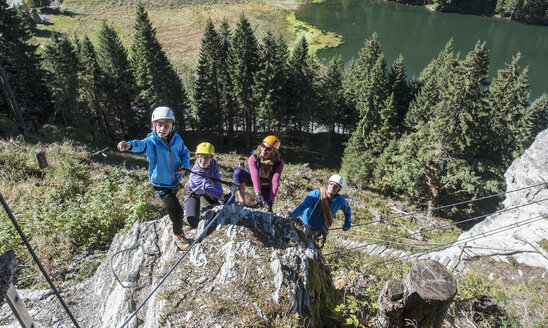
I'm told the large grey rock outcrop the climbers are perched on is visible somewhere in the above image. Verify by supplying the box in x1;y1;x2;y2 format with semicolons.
0;206;335;328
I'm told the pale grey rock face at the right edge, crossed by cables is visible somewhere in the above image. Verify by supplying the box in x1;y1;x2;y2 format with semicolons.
431;130;548;269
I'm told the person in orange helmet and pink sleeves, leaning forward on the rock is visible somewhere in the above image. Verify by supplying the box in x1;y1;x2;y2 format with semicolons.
234;136;284;212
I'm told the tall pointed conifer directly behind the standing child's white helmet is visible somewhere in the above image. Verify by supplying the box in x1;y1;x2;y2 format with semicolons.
130;4;189;130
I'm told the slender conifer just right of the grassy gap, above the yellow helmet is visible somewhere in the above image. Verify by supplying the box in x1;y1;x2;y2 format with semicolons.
194;19;223;132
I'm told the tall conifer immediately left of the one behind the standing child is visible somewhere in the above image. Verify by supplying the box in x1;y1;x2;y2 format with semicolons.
97;22;137;139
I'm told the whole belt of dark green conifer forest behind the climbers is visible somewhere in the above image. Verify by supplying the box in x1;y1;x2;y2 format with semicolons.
0;2;548;210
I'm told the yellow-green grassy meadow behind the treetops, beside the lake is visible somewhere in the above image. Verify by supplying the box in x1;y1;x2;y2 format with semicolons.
35;0;342;72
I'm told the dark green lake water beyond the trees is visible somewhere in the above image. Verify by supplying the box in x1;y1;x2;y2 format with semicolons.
296;0;548;98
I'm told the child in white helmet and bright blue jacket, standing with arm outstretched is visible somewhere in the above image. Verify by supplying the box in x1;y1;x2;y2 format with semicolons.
118;107;190;250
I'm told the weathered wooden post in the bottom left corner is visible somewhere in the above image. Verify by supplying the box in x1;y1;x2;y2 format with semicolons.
0;251;34;328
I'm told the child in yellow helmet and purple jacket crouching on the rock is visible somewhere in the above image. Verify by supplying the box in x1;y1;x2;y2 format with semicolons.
184;142;234;229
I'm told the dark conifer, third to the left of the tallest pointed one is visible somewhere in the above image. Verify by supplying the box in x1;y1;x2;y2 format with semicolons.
43;35;79;125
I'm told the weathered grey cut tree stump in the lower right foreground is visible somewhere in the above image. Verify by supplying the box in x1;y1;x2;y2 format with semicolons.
377;260;457;328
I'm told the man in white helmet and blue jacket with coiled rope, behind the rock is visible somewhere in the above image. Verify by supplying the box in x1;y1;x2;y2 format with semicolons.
290;174;352;247
